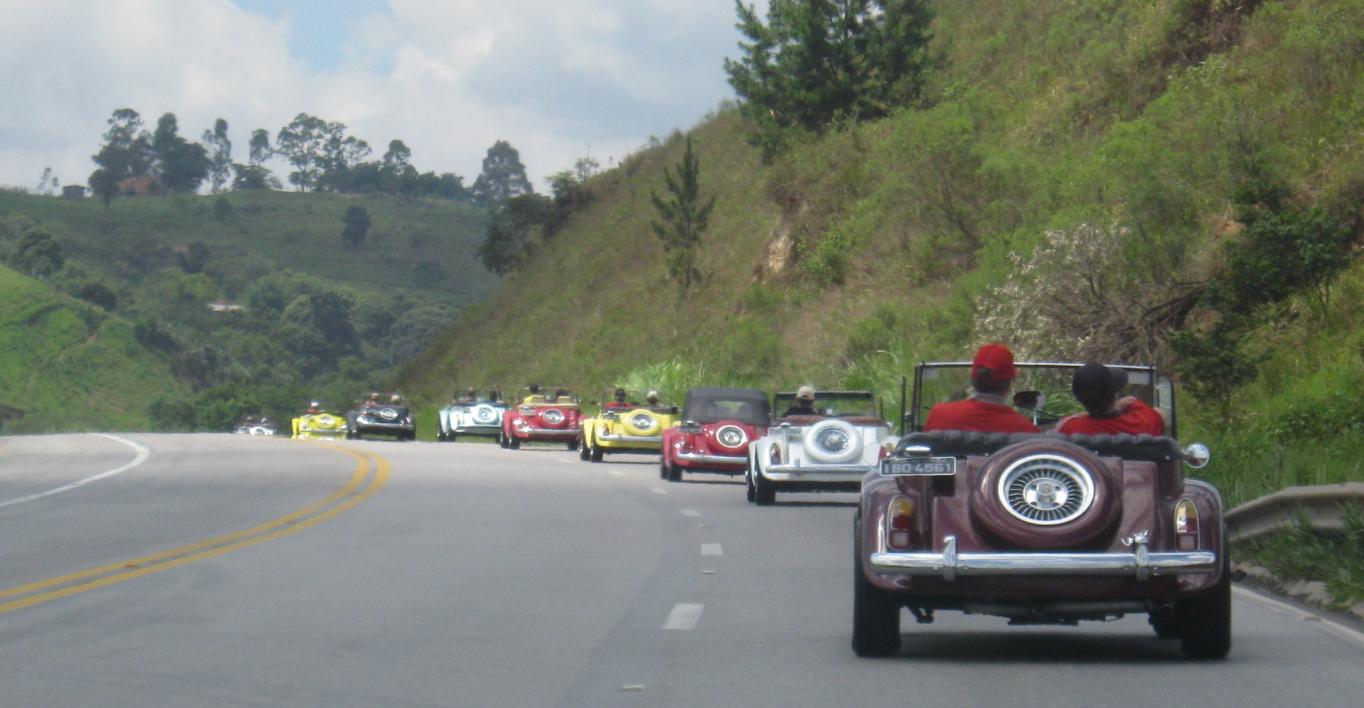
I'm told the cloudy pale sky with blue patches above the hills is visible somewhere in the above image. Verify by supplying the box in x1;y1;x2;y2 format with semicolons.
0;0;767;192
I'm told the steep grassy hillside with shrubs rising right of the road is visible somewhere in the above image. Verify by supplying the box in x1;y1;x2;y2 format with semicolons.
402;0;1364;503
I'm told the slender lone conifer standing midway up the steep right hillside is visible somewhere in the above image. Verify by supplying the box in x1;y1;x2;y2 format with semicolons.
649;136;715;292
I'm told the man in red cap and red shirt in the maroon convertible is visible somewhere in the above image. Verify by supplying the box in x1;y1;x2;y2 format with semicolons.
923;344;1038;432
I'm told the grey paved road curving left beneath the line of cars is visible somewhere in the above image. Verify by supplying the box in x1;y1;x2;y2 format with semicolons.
0;435;1364;707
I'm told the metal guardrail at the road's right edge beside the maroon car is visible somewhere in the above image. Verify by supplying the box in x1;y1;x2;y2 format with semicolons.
1224;482;1364;542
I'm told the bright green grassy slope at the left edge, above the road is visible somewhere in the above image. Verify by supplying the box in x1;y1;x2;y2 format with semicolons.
0;266;186;432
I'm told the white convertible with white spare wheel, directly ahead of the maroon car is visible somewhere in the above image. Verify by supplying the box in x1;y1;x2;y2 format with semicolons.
743;392;898;505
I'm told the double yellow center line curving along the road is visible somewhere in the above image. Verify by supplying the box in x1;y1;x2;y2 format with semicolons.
0;447;389;614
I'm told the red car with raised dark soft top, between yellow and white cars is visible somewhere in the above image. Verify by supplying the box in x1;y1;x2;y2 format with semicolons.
659;389;772;482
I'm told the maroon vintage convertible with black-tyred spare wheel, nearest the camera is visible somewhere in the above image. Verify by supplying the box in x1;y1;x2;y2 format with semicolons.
853;363;1232;659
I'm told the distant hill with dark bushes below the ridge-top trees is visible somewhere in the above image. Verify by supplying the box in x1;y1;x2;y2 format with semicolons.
0;190;498;431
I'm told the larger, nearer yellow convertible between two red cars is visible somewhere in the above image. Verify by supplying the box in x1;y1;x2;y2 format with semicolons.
578;389;678;462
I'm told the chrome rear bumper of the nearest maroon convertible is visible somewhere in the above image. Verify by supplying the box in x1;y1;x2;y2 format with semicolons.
872;536;1217;581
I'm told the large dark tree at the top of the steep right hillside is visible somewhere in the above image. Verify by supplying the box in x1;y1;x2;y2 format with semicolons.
724;0;930;157
